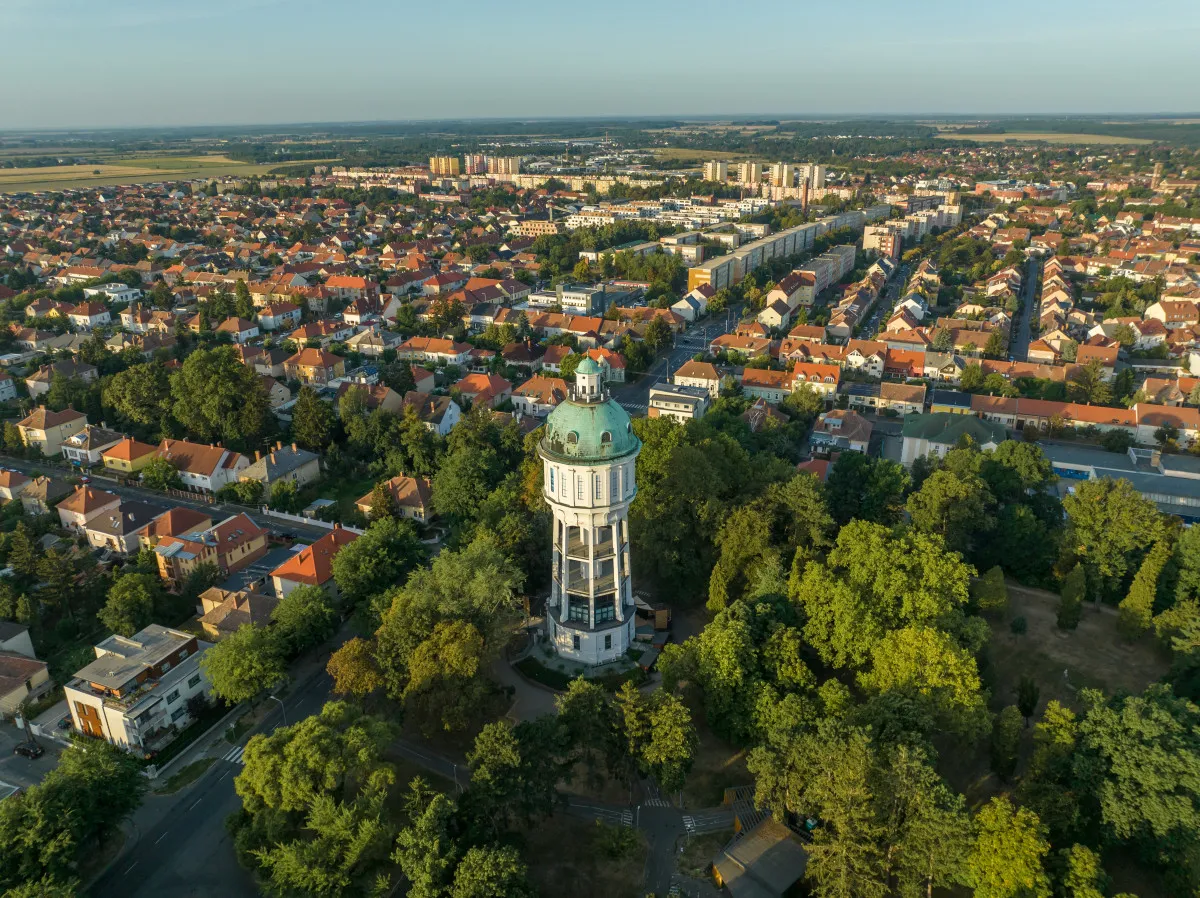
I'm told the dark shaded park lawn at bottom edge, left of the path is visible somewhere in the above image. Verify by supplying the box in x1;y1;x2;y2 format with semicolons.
522;814;648;898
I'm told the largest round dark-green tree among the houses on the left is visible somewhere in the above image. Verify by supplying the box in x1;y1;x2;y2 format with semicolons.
170;346;272;449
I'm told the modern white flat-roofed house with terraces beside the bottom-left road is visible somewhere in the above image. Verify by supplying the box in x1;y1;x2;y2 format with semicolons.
64;623;211;756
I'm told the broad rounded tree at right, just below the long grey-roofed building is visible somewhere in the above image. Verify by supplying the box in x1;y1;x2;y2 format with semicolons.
1062;478;1163;595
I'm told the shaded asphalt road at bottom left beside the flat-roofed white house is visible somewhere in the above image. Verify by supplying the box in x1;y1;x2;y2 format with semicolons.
89;671;332;898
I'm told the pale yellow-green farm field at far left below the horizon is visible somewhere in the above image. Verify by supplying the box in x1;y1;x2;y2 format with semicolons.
0;155;288;193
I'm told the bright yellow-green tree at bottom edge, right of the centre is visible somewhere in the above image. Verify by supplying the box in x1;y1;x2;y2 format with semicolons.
964;797;1050;898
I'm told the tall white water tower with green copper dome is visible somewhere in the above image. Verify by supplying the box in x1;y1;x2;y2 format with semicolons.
539;359;642;664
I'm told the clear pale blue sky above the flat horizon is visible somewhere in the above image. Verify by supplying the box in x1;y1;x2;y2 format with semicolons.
0;0;1200;131
